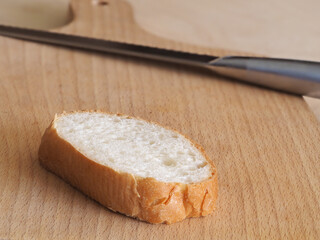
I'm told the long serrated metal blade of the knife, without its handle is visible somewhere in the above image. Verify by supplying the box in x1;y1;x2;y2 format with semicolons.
0;25;217;66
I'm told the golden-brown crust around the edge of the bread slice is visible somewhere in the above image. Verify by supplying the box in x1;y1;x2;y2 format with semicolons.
39;111;218;224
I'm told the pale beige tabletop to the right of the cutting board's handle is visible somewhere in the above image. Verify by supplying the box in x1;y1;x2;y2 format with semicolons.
128;0;320;120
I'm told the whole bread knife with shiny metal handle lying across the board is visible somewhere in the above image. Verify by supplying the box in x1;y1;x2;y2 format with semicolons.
0;25;320;98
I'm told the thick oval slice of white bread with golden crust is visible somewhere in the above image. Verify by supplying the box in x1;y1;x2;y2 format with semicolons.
39;111;218;224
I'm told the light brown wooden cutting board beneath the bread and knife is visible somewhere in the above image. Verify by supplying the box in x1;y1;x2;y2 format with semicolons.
0;0;320;239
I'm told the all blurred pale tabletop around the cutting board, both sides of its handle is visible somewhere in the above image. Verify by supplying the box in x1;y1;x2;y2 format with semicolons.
0;0;320;119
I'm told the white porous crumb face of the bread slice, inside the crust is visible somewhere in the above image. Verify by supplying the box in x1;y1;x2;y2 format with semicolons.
54;112;211;183
